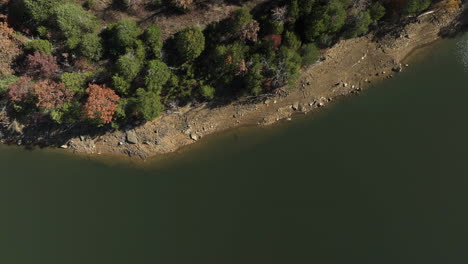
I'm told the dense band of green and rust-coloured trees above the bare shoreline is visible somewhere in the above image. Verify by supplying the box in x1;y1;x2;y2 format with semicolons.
0;0;460;126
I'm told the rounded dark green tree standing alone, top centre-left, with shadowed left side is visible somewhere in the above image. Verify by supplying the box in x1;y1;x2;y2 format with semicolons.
174;26;205;62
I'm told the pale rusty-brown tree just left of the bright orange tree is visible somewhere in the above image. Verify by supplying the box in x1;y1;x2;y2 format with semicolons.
34;81;74;110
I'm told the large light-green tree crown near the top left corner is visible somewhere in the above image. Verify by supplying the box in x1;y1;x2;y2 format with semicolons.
54;4;98;49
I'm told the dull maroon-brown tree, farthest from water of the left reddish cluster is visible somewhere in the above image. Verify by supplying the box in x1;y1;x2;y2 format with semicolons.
26;51;59;79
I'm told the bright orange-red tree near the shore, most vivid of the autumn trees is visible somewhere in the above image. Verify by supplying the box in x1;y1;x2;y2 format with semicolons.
84;84;120;124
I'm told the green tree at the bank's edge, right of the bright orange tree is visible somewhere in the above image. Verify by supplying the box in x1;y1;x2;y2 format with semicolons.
136;88;164;121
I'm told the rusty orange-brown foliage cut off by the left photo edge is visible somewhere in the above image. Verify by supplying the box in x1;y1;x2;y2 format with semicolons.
0;22;21;75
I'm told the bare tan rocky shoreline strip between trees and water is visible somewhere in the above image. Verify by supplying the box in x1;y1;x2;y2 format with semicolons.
0;8;465;159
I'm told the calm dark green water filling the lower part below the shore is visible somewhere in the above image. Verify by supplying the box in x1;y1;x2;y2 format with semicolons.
0;36;468;264
